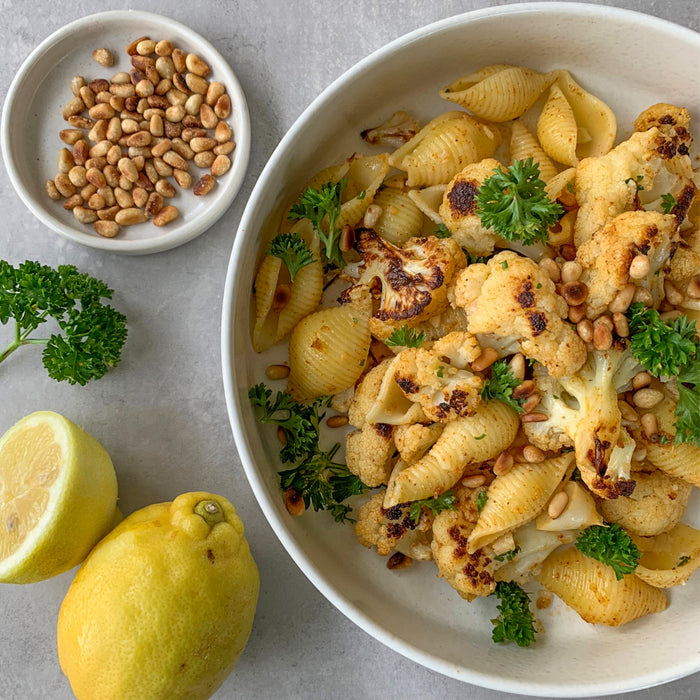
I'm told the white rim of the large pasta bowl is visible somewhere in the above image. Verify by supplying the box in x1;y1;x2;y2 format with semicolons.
221;2;700;698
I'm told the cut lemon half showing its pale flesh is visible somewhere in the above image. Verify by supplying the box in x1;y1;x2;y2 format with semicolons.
0;411;118;583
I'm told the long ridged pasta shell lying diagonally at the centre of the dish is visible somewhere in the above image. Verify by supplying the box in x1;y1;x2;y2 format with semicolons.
384;401;519;508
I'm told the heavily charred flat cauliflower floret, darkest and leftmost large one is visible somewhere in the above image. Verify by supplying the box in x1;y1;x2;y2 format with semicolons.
342;228;466;334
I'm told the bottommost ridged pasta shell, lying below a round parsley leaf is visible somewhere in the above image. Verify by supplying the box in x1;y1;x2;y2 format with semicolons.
537;547;668;627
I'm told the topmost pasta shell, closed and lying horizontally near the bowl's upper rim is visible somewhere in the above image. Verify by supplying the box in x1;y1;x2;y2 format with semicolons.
440;65;557;122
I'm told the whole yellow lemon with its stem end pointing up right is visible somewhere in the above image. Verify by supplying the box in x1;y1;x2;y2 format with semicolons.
58;492;259;700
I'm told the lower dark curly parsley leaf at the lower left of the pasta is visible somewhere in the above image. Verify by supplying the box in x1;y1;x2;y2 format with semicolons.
279;442;368;523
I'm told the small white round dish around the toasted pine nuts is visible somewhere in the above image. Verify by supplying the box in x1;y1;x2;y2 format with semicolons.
2;10;250;255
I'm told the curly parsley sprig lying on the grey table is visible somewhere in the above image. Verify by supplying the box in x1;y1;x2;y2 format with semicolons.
0;260;127;386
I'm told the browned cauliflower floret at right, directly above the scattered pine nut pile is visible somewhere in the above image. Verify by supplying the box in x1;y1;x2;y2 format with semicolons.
576;211;678;319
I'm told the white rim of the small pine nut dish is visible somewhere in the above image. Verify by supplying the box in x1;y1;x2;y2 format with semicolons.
0;10;251;255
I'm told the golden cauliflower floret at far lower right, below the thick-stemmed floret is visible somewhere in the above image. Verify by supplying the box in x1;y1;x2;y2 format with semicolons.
600;465;693;537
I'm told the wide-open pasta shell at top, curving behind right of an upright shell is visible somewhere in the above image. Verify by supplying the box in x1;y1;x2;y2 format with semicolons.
556;70;617;159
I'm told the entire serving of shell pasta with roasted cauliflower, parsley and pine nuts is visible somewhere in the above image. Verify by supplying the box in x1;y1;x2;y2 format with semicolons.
251;64;700;646
